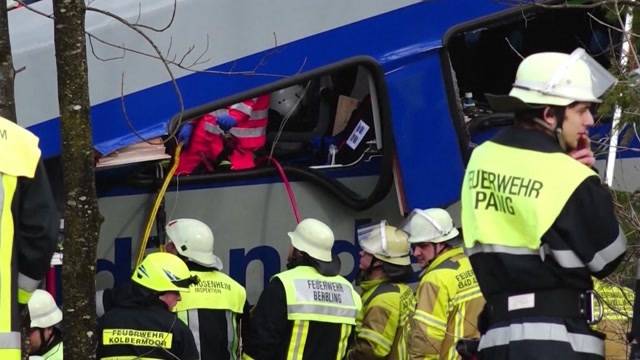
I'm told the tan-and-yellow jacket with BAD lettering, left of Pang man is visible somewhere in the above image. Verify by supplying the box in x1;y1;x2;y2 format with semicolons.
408;247;485;360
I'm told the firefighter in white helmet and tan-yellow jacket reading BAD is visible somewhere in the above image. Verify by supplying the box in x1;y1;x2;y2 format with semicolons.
402;209;485;359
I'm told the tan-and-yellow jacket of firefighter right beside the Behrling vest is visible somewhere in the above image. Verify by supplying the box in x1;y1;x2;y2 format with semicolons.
347;280;416;360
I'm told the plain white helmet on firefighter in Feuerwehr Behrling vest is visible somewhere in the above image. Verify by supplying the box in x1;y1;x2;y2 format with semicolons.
289;218;335;262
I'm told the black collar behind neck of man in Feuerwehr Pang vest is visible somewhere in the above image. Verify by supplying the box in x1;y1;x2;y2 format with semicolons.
491;126;564;152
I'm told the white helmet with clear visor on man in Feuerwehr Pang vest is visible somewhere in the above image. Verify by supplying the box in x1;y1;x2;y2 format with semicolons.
487;48;616;112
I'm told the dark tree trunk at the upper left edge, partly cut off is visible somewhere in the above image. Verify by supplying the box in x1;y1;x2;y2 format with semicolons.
0;0;16;122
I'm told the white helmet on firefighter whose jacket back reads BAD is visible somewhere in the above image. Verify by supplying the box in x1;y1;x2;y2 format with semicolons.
400;208;460;244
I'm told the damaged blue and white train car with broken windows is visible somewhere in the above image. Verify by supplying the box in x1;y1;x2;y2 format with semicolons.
10;0;624;300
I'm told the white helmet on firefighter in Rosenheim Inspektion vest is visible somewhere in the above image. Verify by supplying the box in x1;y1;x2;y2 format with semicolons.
165;219;222;270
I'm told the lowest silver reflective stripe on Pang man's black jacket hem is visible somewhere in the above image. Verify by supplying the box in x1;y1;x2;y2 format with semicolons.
478;323;604;356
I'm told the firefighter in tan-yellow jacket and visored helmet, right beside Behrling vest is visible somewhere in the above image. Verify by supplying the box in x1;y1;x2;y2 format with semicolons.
347;221;416;360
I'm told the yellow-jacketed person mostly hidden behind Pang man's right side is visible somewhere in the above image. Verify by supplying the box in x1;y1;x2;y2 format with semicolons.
593;278;635;360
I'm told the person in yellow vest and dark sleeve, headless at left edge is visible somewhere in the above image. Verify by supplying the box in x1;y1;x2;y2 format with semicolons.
0;117;58;360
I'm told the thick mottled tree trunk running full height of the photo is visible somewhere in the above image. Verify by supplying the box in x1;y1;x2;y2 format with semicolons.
53;0;102;360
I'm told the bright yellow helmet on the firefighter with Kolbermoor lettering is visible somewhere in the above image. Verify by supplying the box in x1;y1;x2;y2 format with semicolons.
131;252;198;292
